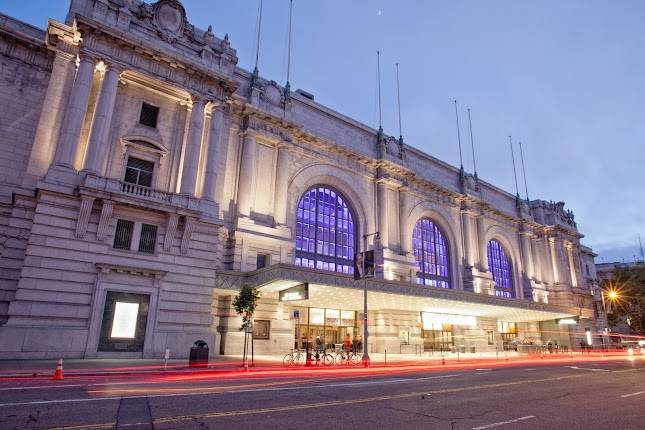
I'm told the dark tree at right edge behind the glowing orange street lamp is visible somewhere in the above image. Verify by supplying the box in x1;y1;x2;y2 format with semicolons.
603;264;645;334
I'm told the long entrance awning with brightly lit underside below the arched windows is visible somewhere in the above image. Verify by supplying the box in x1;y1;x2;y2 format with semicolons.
217;264;593;322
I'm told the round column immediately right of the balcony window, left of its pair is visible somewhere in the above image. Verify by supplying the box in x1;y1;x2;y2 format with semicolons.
180;96;206;196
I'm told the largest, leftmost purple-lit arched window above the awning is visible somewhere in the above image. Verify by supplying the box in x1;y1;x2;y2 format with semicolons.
296;186;356;273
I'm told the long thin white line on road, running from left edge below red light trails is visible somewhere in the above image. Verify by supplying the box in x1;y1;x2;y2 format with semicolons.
0;374;462;408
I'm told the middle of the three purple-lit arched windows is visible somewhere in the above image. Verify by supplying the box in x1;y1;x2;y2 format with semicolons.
412;218;450;288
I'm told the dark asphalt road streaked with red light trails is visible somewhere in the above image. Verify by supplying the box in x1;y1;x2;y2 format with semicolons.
0;357;645;430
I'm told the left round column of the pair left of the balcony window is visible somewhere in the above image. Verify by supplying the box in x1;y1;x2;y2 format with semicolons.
54;56;94;169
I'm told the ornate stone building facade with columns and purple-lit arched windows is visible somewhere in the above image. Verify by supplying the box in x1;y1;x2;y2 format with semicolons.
0;0;598;358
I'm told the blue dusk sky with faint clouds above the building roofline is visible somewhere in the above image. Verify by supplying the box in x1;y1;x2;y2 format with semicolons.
0;0;645;262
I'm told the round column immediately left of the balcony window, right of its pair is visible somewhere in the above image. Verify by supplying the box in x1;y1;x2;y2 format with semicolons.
83;65;121;175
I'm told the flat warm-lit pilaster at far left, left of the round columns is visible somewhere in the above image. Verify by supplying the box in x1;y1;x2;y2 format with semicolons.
27;51;76;178
